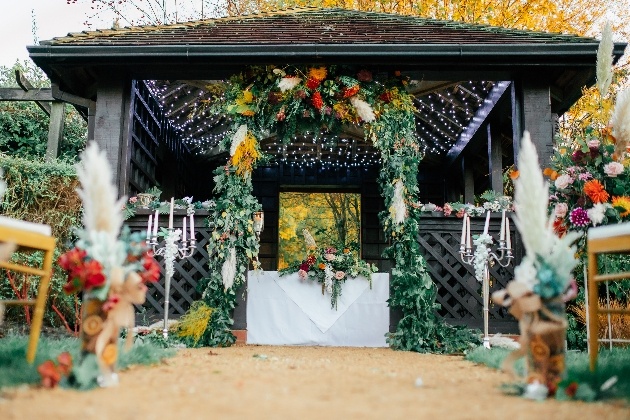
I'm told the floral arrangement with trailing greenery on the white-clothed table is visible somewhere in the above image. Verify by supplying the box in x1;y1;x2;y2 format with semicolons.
279;229;378;309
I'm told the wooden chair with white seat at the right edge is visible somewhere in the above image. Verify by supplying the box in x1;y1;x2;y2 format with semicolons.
586;222;630;371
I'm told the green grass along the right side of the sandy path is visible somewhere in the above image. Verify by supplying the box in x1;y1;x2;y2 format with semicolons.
466;347;630;401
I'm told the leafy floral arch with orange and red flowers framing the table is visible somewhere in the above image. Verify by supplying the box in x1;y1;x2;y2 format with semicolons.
193;66;474;352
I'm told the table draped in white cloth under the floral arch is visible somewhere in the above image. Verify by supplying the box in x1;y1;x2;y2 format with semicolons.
247;271;389;347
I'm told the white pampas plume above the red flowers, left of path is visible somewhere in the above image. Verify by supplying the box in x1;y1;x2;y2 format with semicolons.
77;142;127;275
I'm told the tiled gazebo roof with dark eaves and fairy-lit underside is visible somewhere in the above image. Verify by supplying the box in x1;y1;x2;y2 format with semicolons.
28;8;625;166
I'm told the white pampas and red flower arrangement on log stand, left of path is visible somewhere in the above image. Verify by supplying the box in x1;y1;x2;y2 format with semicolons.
58;143;160;388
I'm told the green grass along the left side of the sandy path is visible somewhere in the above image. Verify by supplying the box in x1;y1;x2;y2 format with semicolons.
0;335;177;388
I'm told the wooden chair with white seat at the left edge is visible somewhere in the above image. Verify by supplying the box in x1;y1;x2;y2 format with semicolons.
0;216;56;363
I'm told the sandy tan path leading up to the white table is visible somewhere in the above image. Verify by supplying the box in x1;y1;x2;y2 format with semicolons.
0;345;630;420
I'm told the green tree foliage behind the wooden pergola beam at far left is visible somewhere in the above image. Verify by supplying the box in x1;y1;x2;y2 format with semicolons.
0;61;87;162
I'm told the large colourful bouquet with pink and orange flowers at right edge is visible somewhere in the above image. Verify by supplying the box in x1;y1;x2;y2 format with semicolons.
544;26;630;241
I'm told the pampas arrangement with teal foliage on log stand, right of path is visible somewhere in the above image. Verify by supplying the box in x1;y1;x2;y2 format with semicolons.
492;132;581;399
